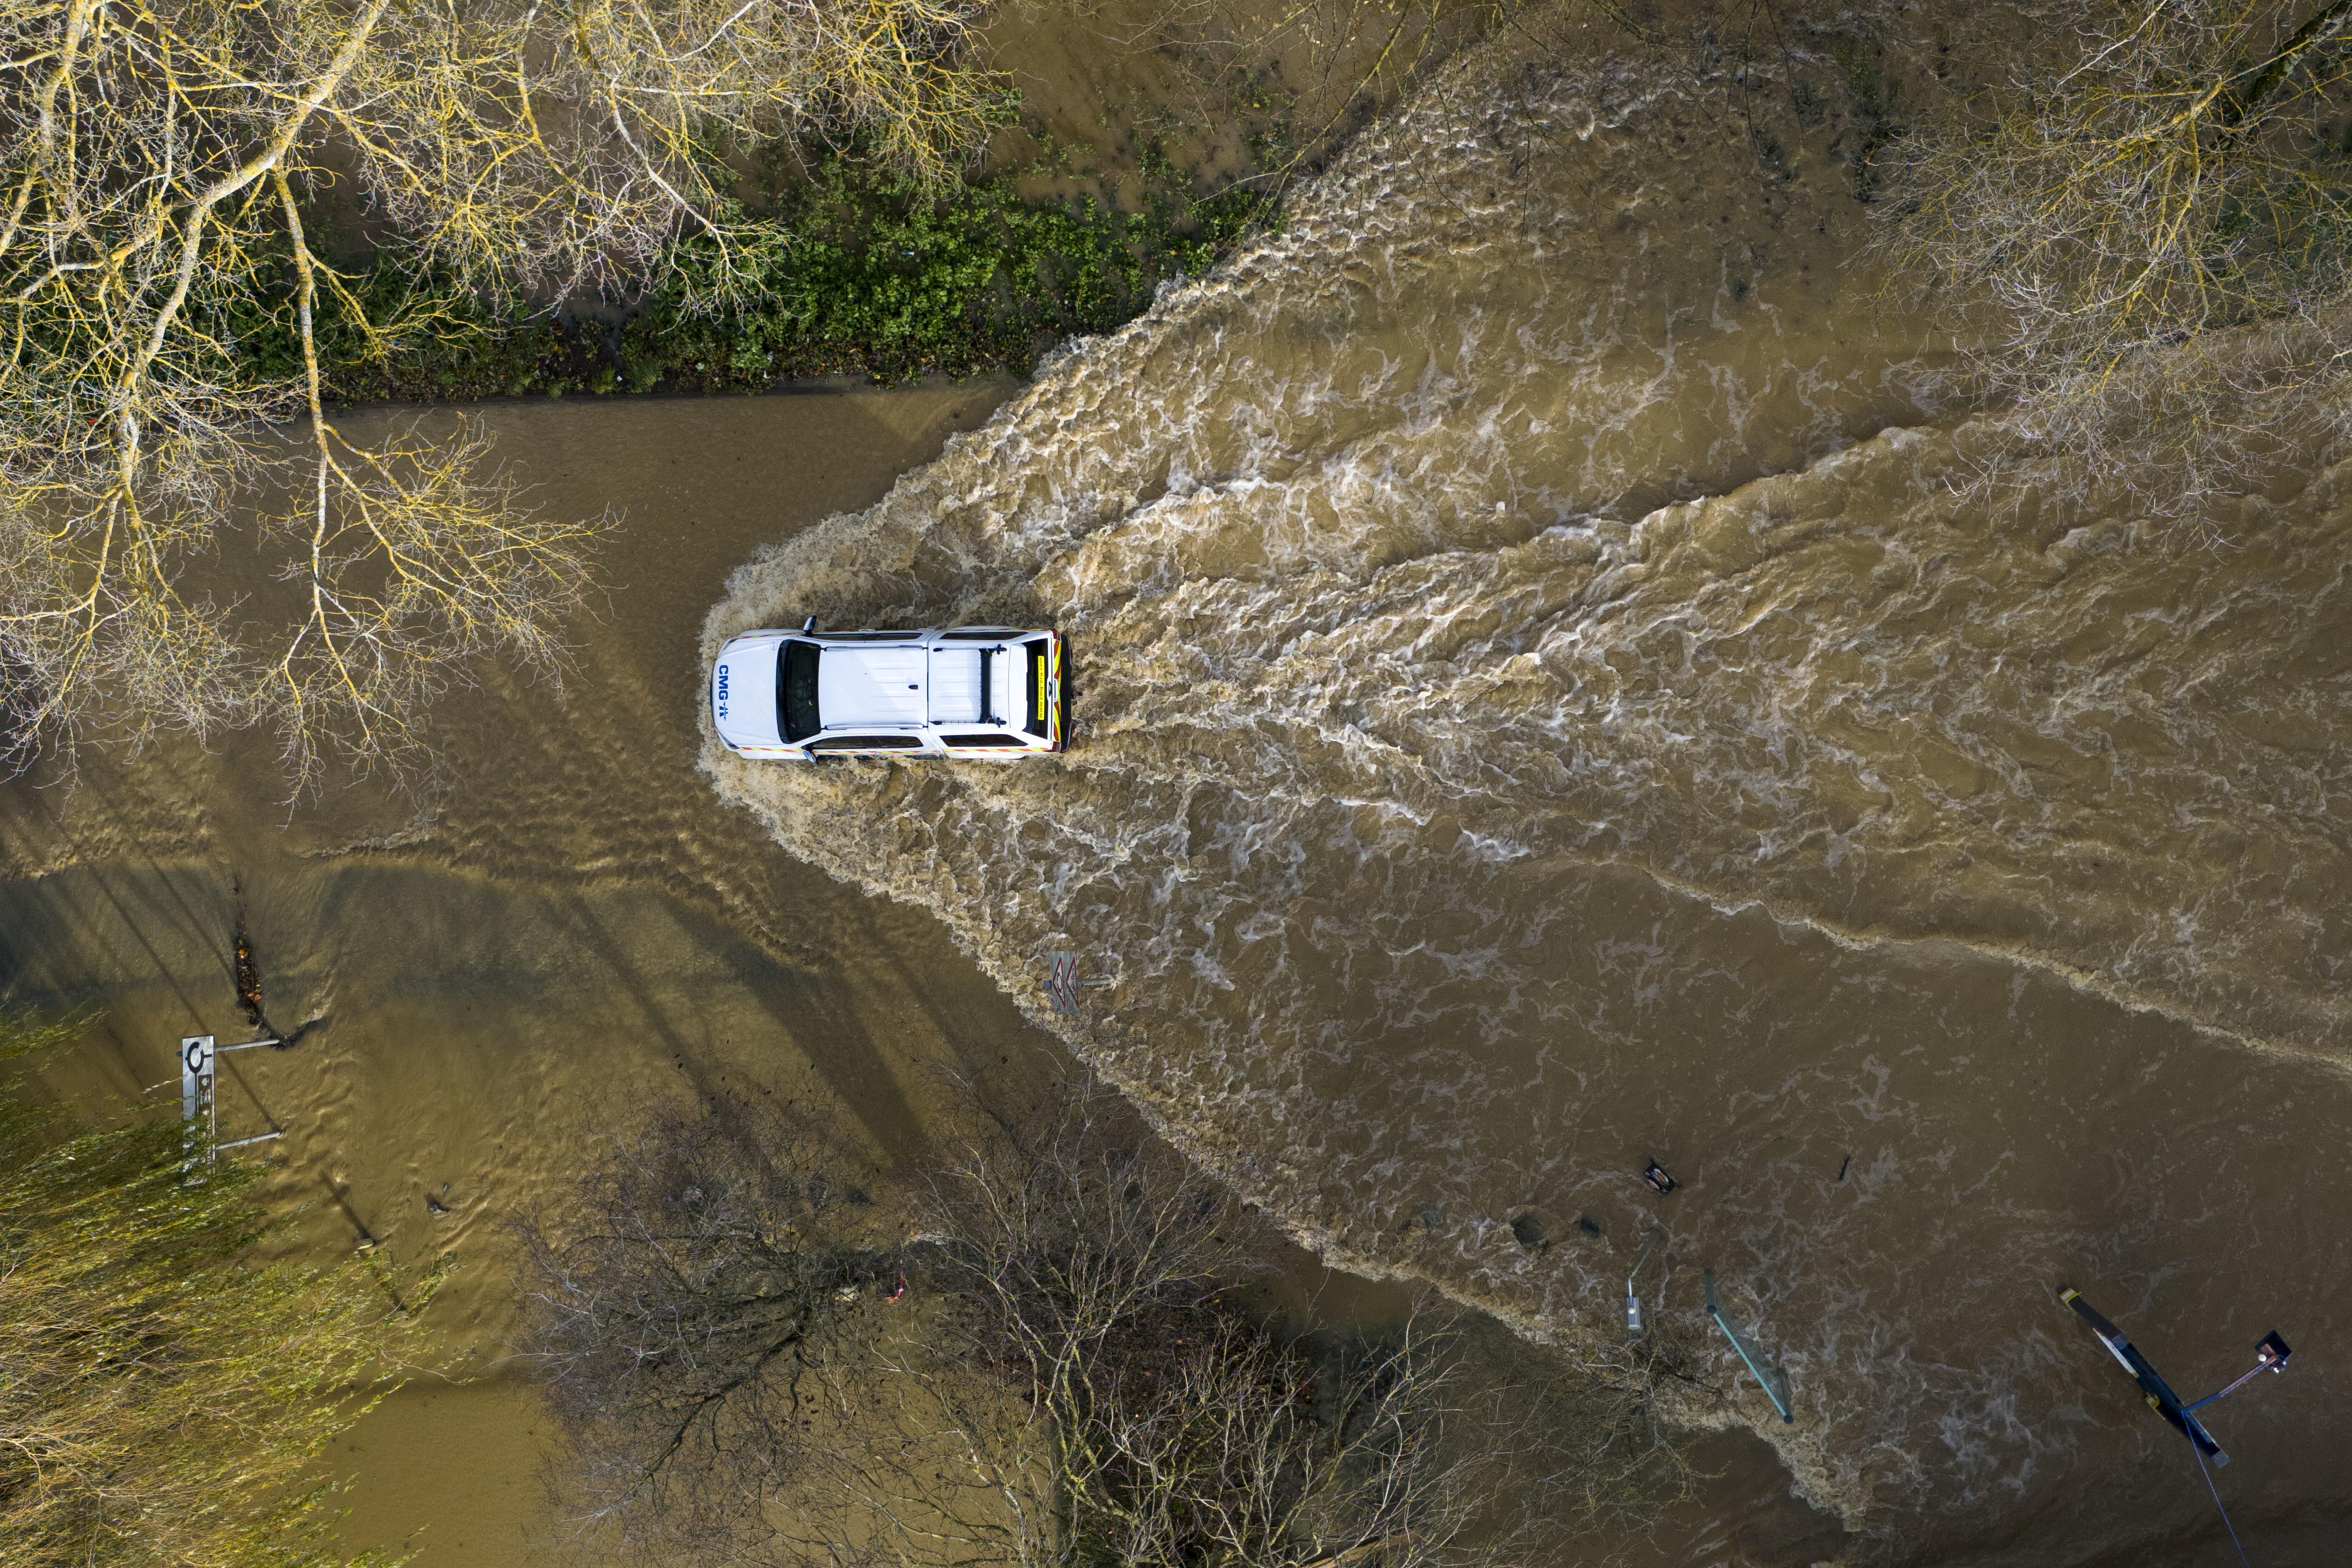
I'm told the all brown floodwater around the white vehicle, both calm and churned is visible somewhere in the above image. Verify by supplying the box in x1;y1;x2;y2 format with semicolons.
0;12;2352;1568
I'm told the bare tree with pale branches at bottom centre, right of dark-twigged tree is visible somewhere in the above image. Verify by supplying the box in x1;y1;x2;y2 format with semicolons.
828;1098;1472;1568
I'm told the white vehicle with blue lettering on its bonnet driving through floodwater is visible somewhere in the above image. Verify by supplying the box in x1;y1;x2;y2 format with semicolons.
710;625;1063;762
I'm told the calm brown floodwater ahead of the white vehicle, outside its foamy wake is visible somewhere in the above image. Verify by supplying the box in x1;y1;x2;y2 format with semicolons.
0;383;1056;1568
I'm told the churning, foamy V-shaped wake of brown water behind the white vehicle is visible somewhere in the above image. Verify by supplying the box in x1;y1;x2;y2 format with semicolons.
703;36;2352;1563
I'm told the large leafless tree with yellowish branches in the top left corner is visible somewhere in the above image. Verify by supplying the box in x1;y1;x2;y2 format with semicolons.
0;0;990;778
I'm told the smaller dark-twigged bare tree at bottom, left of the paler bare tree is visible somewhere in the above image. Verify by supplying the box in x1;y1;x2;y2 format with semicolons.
517;1110;898;1559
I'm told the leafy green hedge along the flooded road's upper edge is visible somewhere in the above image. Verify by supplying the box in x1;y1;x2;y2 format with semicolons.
270;155;1275;402
